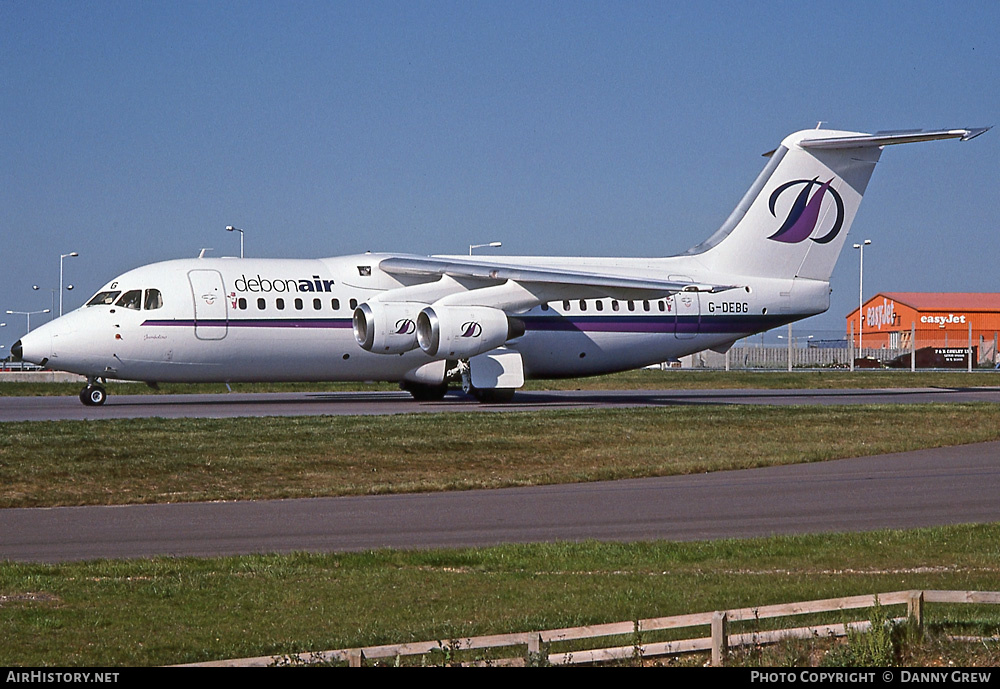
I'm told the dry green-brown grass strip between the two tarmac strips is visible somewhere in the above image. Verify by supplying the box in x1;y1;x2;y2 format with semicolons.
7;404;1000;507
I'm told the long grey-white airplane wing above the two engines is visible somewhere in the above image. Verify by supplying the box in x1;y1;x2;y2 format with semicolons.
379;256;736;298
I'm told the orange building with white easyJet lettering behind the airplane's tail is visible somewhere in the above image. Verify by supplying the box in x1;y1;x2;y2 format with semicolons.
847;292;1000;360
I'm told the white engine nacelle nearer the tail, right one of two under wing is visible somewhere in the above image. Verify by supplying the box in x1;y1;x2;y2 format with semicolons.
417;306;524;359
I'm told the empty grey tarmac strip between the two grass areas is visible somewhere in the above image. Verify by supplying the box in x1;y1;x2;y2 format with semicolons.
0;442;1000;562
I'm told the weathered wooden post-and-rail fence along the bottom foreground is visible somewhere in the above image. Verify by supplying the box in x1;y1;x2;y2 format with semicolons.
184;590;1000;667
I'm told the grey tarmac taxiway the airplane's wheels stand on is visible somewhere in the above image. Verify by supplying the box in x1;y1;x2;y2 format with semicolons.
0;387;1000;422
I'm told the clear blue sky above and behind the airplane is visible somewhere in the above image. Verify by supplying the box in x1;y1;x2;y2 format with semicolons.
0;0;1000;346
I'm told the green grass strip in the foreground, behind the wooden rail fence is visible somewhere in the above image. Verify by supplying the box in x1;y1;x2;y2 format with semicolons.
0;524;1000;666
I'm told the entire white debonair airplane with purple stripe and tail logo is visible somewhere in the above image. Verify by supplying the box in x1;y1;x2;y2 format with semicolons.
11;127;989;405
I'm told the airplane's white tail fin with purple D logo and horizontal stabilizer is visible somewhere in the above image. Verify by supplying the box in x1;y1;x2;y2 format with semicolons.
688;127;989;281
